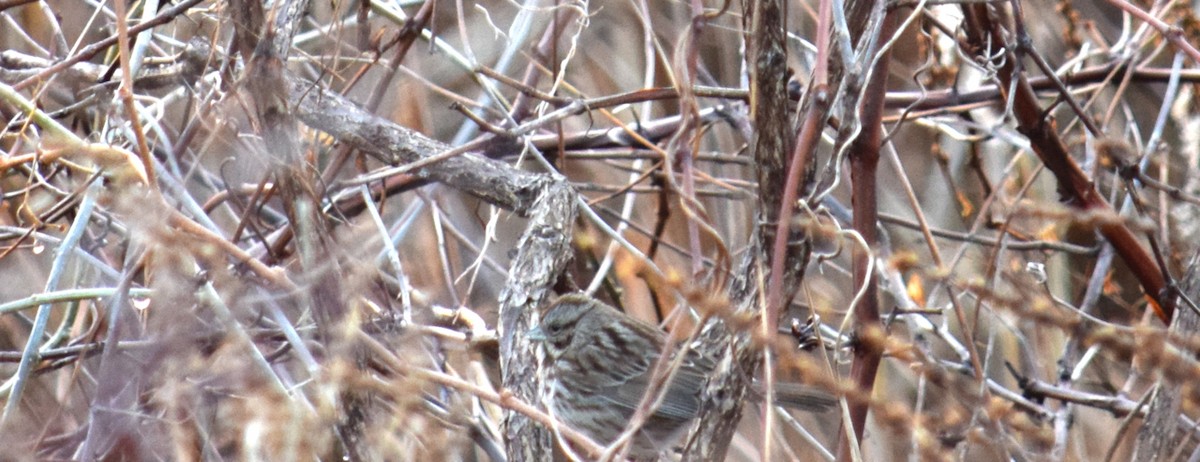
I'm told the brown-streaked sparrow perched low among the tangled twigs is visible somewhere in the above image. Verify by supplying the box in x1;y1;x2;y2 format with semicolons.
529;294;713;458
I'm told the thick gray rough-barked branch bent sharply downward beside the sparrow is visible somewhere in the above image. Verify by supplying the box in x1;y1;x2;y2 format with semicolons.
289;78;576;461
